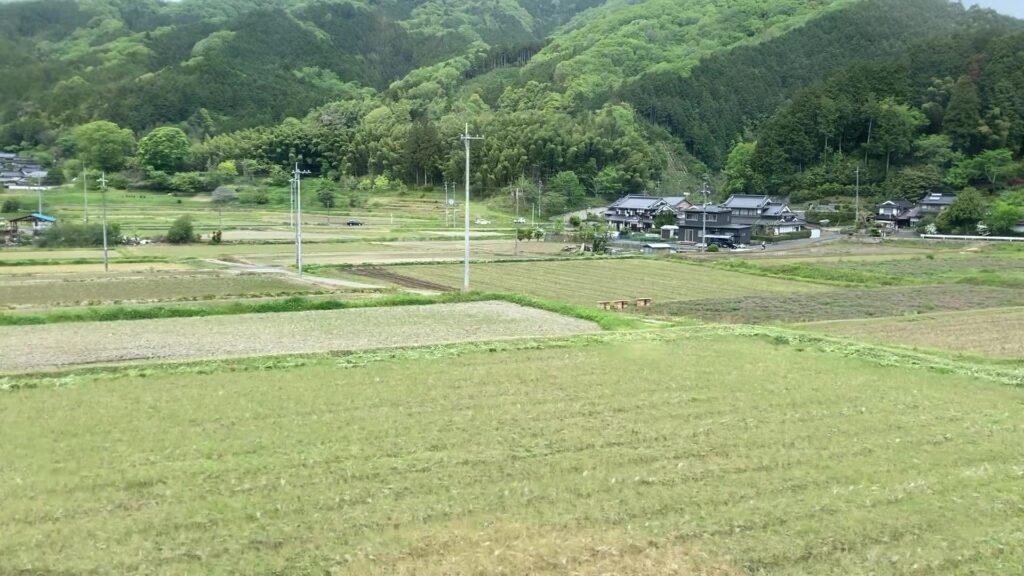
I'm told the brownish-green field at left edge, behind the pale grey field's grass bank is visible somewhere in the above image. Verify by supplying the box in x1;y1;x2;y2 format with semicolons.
0;271;317;308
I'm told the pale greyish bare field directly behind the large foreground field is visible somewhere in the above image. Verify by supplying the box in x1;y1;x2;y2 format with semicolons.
0;302;599;371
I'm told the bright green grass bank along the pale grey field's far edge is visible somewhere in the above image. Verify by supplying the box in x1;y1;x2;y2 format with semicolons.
0;292;649;330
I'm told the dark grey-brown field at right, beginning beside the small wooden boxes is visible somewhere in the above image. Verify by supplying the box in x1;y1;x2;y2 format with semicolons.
646;284;1024;324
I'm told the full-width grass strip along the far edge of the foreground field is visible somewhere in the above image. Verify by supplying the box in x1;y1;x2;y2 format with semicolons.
0;323;1024;392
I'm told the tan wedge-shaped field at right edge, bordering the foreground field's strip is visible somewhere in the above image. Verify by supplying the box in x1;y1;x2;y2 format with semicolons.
803;308;1024;360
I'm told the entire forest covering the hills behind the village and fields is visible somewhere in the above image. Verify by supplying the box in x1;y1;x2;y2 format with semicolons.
0;0;1024;228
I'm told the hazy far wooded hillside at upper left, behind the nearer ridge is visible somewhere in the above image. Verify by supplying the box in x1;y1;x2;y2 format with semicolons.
0;0;599;130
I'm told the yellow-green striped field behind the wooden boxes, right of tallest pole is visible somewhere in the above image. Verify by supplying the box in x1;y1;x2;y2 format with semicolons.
389;258;826;305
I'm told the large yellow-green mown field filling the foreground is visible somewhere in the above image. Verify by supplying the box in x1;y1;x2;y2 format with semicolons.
0;331;1024;575
